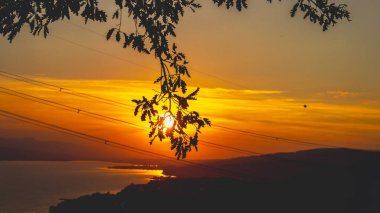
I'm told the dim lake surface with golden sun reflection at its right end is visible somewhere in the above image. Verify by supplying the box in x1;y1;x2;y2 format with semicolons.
0;161;163;213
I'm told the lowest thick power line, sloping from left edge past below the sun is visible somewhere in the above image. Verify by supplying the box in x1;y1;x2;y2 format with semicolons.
0;109;253;178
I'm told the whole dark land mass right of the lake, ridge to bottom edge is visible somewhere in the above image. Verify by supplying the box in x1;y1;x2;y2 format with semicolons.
50;149;380;213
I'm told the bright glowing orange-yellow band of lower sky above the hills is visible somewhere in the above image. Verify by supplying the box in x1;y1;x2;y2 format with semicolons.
0;79;380;159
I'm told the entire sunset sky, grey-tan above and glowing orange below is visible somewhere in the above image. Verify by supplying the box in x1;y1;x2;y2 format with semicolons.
0;0;380;159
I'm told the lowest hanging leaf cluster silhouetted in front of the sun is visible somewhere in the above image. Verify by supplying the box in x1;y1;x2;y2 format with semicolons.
133;44;211;159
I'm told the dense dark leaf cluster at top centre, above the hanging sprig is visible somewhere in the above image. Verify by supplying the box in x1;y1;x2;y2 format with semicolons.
107;0;201;57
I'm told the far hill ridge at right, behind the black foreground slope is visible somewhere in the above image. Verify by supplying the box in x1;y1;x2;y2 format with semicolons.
164;149;380;179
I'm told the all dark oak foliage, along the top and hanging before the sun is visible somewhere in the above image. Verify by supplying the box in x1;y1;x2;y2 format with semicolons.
0;0;350;159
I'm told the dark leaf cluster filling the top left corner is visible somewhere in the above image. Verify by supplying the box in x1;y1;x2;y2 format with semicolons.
0;0;107;42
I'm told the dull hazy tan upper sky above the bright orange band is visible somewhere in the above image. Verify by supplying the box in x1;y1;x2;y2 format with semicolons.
0;0;380;92
